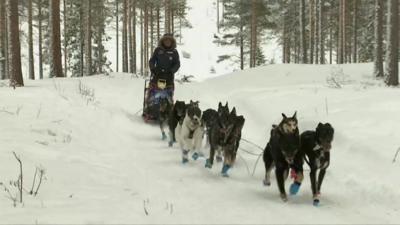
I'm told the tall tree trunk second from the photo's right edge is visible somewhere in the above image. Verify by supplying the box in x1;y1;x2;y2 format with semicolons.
374;0;384;77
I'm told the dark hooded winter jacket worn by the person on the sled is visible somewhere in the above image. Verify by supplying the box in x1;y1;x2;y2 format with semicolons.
149;35;181;86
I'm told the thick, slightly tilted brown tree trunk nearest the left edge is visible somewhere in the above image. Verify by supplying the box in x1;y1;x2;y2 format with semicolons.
7;0;24;87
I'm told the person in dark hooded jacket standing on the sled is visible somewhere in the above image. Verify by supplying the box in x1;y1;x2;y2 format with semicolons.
149;34;181;98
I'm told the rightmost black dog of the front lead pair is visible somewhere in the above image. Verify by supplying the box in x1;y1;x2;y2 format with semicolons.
300;123;334;206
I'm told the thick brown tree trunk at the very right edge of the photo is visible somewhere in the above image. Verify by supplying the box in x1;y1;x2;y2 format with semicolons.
386;0;399;86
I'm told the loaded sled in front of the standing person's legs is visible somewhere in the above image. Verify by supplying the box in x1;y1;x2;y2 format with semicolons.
142;79;174;123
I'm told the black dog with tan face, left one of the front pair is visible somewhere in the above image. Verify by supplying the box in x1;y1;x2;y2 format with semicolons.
263;113;302;201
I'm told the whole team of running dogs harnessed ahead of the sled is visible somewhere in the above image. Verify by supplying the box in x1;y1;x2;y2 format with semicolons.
159;98;334;206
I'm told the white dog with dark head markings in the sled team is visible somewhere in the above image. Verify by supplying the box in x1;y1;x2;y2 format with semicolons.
175;101;204;163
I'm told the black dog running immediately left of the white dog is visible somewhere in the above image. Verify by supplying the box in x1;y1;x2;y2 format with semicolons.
168;101;186;147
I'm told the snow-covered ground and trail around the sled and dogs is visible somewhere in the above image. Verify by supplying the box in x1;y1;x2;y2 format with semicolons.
0;64;400;224
